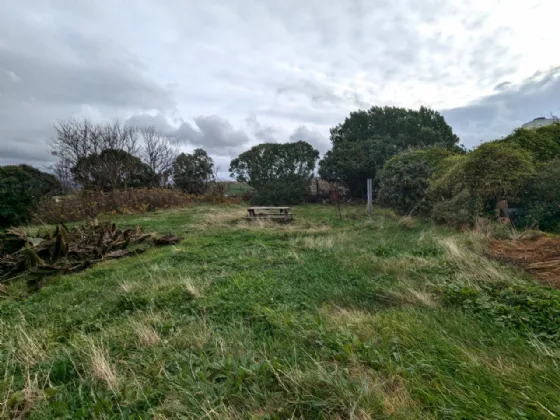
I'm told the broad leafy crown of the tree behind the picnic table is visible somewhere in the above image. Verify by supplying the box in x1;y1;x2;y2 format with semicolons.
229;141;319;188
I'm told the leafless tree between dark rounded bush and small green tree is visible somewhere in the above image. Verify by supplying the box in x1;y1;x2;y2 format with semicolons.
139;127;179;184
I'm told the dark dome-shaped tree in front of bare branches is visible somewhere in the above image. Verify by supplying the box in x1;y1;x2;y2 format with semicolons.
71;149;156;191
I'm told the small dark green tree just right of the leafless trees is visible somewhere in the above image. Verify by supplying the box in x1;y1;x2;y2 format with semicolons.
172;149;214;194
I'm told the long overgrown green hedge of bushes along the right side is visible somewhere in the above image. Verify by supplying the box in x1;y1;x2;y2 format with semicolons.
379;124;560;231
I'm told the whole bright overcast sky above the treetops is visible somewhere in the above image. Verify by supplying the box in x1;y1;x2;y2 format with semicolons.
0;0;560;171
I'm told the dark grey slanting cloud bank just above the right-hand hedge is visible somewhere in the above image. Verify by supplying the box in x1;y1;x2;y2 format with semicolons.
441;67;560;147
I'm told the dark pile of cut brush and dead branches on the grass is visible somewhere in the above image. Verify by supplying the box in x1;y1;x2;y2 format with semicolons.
0;219;182;290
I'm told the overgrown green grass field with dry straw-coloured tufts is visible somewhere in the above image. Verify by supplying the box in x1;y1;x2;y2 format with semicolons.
0;206;560;419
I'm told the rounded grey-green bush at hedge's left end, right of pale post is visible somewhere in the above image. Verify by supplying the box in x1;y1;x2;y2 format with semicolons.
379;148;451;214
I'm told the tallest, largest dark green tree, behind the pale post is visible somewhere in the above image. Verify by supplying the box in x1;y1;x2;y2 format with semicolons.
319;106;461;196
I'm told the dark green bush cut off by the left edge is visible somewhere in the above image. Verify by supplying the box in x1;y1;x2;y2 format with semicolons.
0;165;60;227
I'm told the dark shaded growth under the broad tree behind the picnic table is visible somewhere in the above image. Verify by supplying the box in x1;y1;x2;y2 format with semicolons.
251;179;307;206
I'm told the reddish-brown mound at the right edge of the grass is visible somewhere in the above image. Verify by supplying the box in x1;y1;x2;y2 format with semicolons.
489;236;560;289
